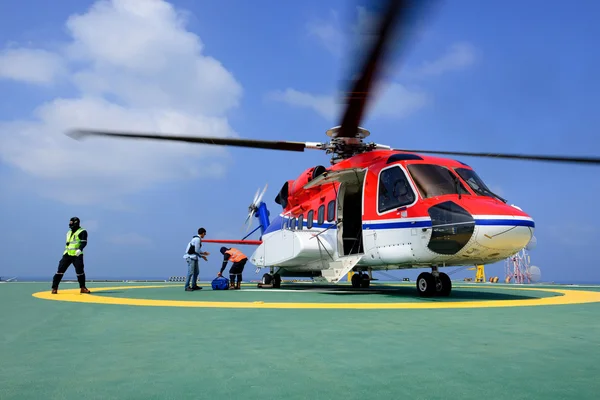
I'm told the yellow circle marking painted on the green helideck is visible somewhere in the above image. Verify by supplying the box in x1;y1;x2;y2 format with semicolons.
32;285;600;310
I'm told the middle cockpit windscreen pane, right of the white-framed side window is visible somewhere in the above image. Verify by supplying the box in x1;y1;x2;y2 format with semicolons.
408;164;469;199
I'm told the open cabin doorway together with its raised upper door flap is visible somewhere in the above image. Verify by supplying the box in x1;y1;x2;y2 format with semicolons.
304;168;367;257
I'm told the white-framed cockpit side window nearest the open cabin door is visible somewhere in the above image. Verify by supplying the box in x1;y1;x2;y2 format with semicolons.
377;166;415;213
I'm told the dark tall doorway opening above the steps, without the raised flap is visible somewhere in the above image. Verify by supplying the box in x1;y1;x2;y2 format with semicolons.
338;177;364;257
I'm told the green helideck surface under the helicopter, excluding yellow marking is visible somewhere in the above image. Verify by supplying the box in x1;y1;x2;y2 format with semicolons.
0;283;600;400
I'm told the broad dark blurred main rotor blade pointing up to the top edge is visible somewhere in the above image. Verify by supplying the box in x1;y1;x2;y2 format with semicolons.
335;0;422;137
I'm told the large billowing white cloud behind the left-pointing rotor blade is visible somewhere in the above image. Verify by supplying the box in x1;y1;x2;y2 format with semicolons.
0;0;242;204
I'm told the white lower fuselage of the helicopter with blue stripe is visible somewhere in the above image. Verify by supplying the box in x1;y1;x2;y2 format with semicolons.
251;215;534;271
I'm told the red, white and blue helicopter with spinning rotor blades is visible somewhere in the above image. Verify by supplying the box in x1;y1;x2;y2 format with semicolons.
68;0;600;297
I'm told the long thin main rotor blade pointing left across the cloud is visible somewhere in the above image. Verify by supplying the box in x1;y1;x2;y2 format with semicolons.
67;129;314;152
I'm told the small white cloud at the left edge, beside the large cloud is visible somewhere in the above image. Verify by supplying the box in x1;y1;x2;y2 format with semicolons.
0;49;66;85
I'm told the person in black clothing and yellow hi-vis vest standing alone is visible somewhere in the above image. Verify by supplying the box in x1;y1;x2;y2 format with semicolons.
52;217;90;294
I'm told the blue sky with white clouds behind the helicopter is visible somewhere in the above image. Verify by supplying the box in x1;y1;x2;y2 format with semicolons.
0;0;600;282
